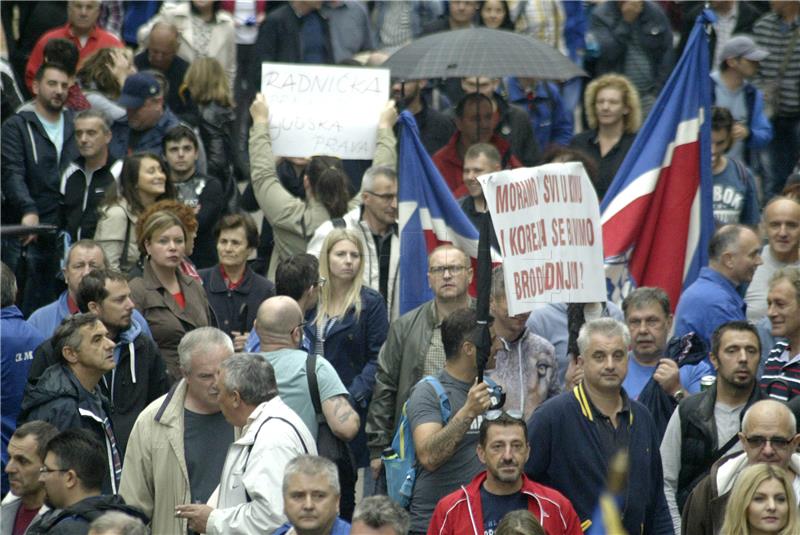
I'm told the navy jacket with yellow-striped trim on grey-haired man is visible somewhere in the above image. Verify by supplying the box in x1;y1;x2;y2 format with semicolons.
525;385;674;535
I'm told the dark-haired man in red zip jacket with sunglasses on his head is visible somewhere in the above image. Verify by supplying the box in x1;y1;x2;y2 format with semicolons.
428;411;583;535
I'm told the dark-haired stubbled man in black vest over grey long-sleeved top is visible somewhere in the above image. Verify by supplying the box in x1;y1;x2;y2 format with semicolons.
661;321;765;533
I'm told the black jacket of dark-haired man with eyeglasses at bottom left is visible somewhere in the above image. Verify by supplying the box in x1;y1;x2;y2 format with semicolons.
26;494;150;535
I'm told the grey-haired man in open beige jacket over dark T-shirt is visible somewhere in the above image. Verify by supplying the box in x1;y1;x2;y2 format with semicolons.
120;327;234;533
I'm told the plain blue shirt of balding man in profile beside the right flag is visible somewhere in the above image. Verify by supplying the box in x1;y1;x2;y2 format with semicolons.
675;267;747;347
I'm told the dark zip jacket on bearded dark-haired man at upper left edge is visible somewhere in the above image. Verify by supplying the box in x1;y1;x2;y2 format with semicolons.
0;103;78;225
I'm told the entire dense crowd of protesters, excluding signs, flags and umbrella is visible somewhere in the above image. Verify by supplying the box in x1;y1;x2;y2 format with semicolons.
0;0;800;535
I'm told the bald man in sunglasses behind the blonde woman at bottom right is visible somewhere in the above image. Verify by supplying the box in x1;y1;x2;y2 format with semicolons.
682;399;800;535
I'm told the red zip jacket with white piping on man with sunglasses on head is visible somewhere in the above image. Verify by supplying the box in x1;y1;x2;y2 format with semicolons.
428;471;583;535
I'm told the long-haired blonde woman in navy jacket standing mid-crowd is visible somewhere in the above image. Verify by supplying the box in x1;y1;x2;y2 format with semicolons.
305;228;389;515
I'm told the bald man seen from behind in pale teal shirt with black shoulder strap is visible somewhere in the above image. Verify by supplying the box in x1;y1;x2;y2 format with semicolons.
256;295;360;442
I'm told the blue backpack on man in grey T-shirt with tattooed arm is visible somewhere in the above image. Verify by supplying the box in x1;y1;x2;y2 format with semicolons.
381;375;450;508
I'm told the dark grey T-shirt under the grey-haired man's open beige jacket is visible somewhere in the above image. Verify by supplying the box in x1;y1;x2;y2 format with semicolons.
183;409;233;503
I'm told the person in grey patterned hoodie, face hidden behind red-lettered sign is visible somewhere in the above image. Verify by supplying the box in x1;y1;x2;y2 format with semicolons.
487;266;561;421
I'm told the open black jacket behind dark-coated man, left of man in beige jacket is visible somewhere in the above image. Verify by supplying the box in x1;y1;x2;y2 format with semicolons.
28;316;169;457
